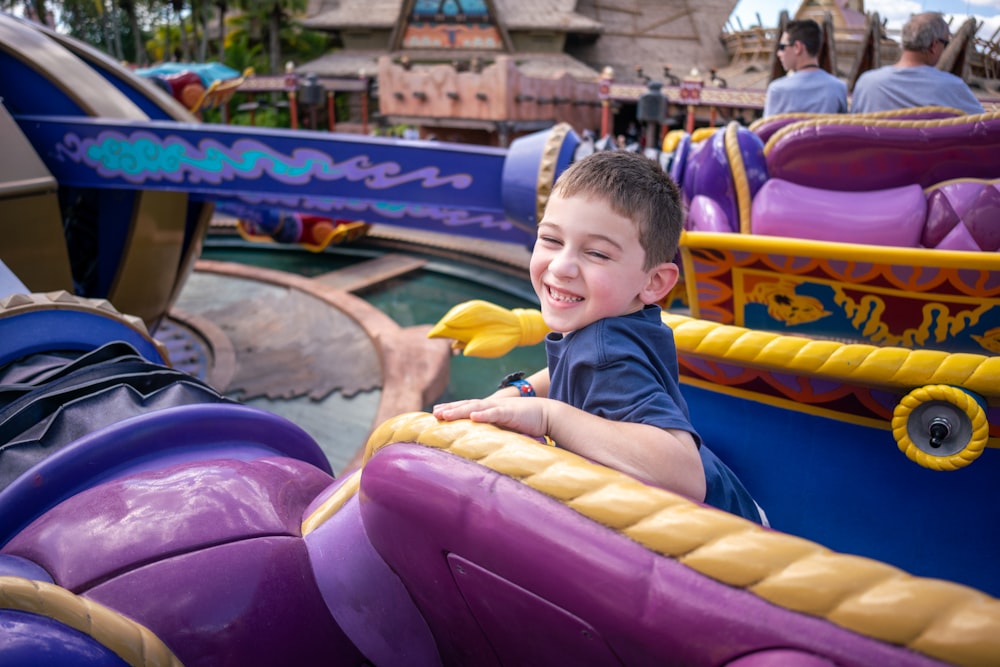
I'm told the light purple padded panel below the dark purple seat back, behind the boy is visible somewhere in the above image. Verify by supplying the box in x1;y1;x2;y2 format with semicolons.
750;178;927;247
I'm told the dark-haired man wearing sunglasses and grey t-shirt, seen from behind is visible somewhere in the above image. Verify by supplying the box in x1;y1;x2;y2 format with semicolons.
764;19;847;118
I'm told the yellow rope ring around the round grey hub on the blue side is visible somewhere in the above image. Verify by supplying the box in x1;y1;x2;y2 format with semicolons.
892;384;990;470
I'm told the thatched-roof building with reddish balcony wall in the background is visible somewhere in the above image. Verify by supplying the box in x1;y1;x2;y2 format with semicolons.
296;0;736;146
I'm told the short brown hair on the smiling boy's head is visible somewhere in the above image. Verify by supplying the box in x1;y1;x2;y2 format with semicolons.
552;151;684;270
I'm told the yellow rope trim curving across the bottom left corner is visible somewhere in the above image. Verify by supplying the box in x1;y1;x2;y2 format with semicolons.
0;576;182;667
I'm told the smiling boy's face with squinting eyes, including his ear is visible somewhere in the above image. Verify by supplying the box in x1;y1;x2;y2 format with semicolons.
530;195;669;333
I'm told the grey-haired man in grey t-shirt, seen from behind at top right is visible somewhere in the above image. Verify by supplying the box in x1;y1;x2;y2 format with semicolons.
851;12;983;114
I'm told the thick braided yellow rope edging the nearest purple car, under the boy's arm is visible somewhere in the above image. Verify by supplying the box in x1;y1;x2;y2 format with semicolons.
365;413;1000;667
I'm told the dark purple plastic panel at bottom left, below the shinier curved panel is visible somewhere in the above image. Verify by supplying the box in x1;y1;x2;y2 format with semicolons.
87;537;364;667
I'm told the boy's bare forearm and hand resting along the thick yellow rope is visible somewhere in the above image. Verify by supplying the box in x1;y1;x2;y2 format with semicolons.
434;396;705;502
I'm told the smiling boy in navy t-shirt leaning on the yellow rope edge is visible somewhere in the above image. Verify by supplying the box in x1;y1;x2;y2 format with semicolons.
433;151;761;522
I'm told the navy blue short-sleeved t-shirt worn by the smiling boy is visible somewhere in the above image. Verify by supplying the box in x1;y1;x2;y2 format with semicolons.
545;306;760;523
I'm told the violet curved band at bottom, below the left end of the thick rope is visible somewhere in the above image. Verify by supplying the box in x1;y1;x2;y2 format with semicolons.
305;496;441;667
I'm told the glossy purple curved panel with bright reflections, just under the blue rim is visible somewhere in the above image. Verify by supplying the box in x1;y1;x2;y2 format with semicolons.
3;458;330;593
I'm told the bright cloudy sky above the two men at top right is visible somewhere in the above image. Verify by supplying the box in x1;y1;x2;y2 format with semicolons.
730;0;1000;39
